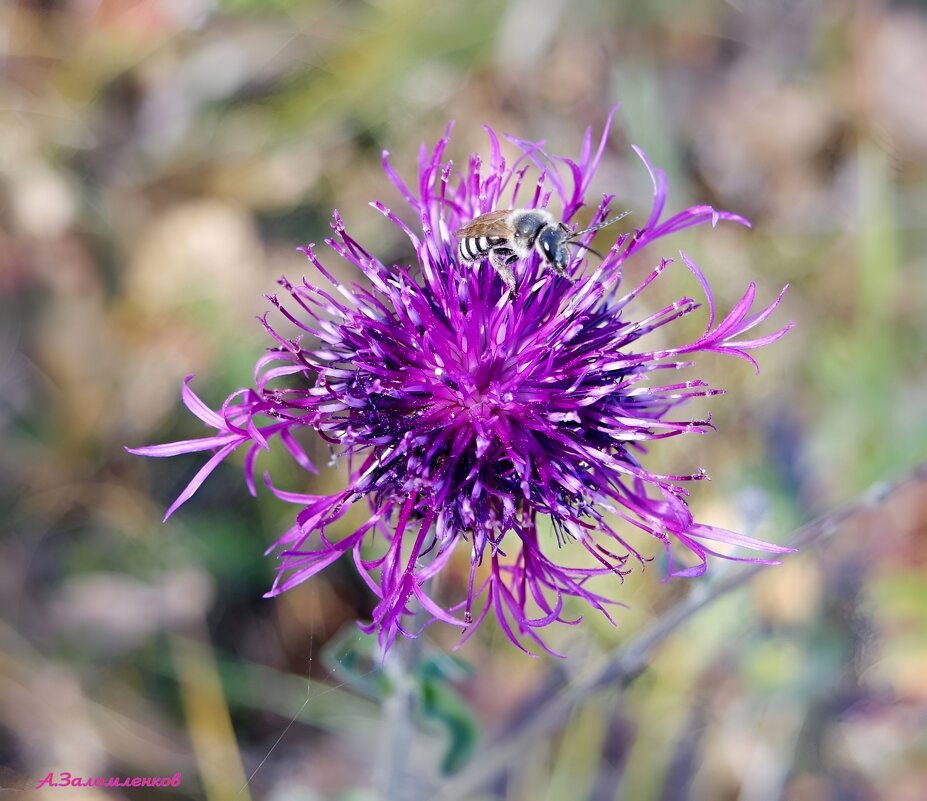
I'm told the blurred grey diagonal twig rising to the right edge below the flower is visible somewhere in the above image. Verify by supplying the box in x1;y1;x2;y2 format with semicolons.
433;462;927;801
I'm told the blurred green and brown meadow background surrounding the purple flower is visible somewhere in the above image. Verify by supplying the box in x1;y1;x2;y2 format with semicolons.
0;0;927;801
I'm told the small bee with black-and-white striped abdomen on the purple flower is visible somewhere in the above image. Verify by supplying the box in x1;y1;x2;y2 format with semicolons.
454;209;630;299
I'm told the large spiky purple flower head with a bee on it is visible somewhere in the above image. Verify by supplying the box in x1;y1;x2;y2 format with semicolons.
132;106;791;648
